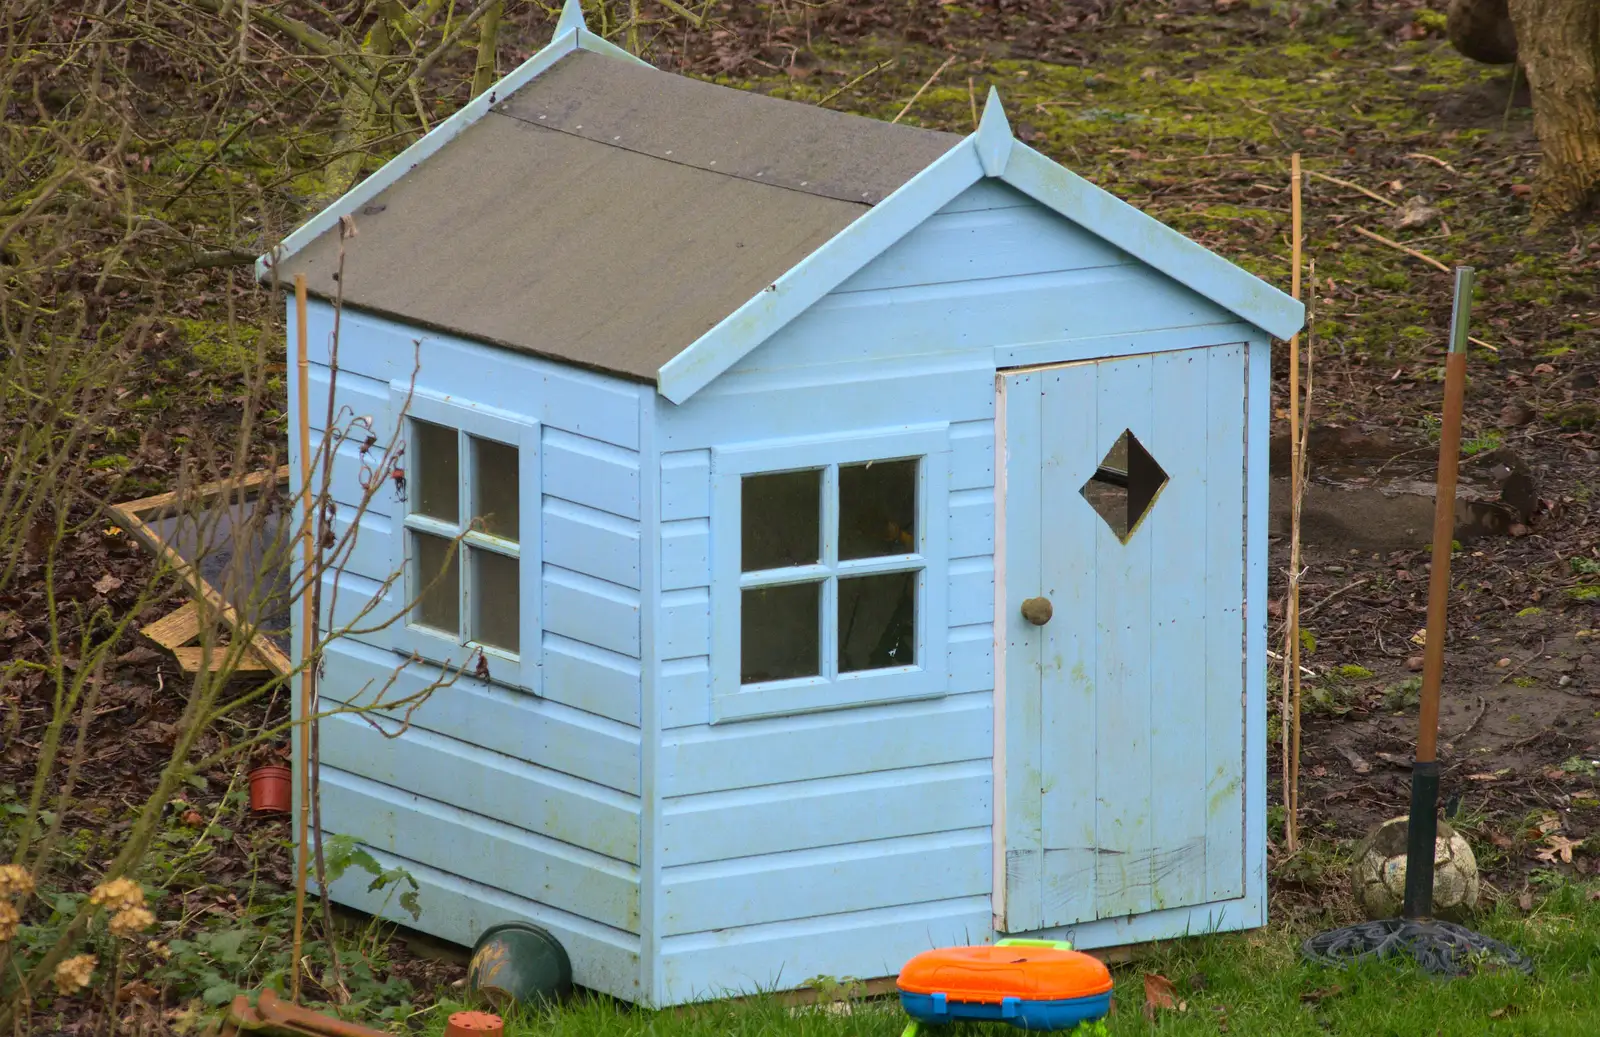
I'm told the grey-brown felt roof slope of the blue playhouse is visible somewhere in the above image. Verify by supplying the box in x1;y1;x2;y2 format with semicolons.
280;50;963;382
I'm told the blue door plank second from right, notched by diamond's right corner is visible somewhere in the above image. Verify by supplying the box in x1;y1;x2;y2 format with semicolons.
1139;349;1203;907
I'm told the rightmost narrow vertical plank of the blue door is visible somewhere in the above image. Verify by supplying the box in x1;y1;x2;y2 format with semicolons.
1205;346;1259;901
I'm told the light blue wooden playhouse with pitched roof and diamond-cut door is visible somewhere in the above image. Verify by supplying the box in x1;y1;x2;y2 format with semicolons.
258;0;1302;1005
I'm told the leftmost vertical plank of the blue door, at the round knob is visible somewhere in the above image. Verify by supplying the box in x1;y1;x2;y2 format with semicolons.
995;371;1043;933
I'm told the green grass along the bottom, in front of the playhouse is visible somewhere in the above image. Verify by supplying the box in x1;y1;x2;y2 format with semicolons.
422;883;1600;1037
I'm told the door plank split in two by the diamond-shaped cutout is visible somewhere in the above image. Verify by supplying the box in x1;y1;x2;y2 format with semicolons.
1094;357;1155;919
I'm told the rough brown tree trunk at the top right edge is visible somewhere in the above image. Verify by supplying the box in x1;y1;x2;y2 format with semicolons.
1509;0;1600;226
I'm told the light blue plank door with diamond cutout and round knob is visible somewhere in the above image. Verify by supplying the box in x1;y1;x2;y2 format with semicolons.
997;344;1246;933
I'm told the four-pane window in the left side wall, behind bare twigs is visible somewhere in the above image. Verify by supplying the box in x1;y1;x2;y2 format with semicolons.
392;389;541;691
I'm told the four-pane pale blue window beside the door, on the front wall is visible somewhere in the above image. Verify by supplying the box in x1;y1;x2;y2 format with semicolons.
712;426;949;722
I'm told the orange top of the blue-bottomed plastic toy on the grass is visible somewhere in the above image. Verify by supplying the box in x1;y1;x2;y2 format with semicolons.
899;941;1112;1005
